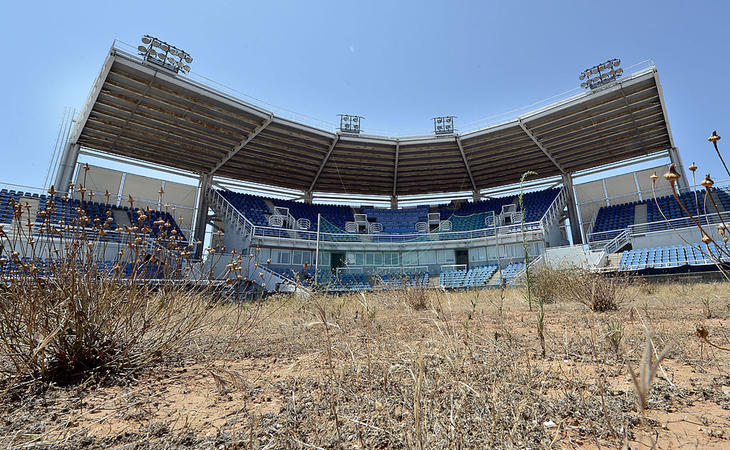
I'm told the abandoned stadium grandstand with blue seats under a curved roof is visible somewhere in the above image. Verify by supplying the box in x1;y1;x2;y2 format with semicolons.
0;37;730;292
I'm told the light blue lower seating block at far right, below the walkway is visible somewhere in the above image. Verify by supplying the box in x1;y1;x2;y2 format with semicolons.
619;244;726;271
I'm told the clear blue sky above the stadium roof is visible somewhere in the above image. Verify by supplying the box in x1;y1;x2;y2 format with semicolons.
0;1;730;186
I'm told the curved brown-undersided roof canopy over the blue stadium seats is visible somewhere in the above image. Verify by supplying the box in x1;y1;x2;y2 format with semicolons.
71;48;673;196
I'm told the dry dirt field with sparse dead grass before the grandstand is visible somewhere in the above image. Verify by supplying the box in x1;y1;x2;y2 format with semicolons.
0;283;730;449
